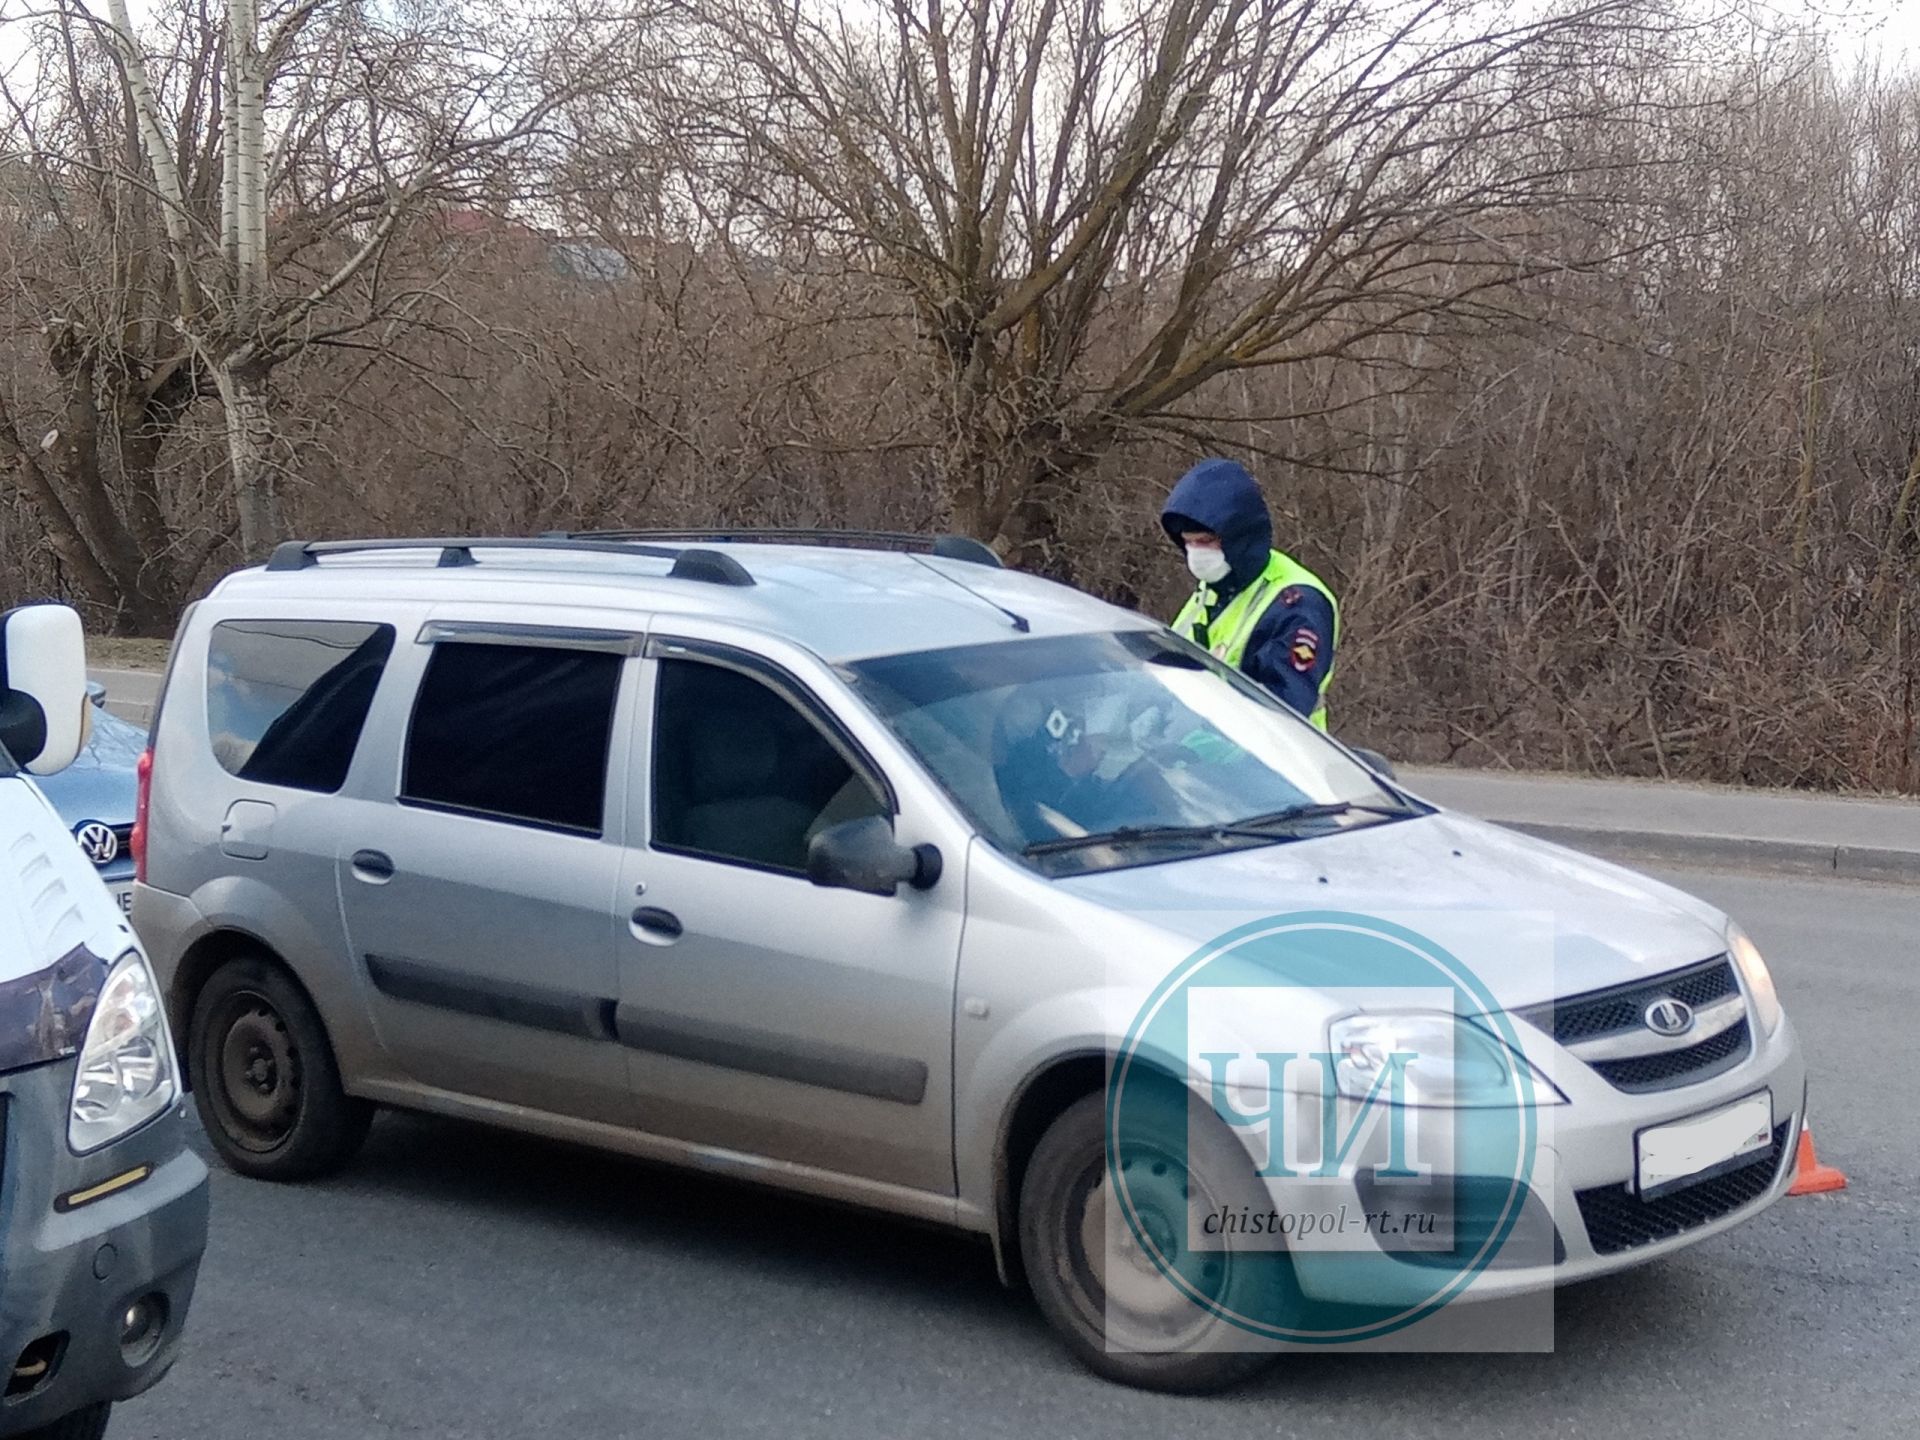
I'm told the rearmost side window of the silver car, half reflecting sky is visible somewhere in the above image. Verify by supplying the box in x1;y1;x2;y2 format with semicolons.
207;620;394;793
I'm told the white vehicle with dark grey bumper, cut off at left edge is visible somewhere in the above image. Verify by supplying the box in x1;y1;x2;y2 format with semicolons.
0;605;207;1440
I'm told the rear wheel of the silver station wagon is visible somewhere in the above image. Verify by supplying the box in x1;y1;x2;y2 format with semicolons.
186;956;372;1181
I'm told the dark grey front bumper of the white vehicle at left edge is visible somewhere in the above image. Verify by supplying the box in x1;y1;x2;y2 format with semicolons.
0;1060;207;1436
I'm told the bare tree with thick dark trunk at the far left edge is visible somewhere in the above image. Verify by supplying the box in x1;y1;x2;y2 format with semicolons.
0;2;230;630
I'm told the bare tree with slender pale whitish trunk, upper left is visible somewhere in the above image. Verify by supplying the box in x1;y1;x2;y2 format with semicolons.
8;0;641;602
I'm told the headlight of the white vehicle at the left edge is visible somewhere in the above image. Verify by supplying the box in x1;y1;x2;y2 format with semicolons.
67;950;180;1156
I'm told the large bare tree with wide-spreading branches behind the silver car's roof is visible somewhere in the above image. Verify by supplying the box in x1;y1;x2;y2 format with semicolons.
641;0;1681;568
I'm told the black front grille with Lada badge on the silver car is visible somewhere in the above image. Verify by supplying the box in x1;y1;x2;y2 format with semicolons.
1517;954;1753;1094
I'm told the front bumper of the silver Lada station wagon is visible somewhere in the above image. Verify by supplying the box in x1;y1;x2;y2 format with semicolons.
1269;1020;1807;1306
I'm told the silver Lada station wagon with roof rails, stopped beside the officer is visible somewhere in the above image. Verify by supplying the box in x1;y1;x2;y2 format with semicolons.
132;532;1805;1390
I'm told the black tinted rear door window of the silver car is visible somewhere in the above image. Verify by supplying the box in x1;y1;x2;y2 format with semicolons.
399;641;622;835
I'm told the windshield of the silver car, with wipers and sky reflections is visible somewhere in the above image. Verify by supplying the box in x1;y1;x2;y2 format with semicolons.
847;630;1425;874
